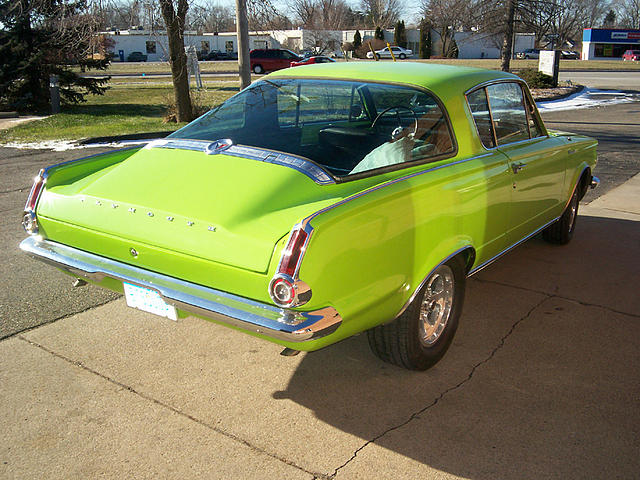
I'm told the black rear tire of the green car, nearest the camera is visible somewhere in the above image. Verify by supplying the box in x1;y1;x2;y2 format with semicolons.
367;256;466;370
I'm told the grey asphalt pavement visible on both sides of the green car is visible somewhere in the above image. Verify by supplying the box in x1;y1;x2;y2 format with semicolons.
0;103;640;338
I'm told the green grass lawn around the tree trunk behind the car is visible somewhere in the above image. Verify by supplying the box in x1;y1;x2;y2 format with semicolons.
0;82;238;143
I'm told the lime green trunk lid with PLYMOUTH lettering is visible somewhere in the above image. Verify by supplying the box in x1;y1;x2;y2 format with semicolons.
38;148;337;272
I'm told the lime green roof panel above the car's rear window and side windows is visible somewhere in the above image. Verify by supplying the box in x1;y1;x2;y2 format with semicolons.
268;62;518;97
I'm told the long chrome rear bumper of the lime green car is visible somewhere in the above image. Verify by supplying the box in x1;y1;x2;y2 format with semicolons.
20;236;342;342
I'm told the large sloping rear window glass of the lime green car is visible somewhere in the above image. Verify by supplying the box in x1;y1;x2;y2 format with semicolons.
169;79;453;177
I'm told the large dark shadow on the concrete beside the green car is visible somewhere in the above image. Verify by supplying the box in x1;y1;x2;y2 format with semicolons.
273;216;640;479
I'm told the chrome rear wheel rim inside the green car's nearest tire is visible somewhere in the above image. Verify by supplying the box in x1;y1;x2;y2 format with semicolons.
419;265;455;347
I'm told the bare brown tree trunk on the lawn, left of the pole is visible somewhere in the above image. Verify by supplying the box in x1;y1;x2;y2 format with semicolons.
160;0;194;122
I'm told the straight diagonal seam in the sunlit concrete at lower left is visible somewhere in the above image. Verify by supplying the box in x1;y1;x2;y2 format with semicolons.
16;334;322;480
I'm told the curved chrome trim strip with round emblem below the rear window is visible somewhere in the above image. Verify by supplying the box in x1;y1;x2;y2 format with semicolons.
144;138;336;185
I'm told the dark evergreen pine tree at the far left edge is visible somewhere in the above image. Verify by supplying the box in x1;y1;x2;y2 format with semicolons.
0;0;109;111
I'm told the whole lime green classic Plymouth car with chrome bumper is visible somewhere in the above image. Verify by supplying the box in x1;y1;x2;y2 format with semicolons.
21;62;598;370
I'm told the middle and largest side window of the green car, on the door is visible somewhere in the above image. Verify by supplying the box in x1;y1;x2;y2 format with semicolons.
487;82;529;145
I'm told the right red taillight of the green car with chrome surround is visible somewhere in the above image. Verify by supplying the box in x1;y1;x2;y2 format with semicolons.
269;225;313;307
